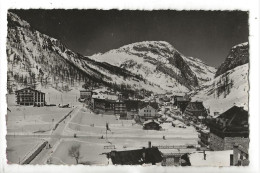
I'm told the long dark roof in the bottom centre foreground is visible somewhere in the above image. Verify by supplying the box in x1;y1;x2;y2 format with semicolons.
110;147;162;165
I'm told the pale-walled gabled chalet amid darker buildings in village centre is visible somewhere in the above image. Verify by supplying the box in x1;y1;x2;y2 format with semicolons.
138;102;159;120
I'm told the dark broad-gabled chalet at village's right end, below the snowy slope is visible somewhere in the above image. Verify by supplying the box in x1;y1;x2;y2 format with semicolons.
184;102;207;121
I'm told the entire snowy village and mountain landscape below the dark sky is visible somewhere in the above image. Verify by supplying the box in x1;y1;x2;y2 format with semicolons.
6;12;249;166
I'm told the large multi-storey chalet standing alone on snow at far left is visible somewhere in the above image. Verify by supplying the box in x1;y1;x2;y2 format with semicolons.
15;87;45;107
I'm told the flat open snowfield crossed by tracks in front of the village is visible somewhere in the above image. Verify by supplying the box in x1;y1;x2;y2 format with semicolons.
6;95;198;165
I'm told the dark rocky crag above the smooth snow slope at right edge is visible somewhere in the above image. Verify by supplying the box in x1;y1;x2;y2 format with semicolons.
215;42;249;76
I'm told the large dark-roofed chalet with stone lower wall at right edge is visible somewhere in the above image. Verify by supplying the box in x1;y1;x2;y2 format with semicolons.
208;106;249;150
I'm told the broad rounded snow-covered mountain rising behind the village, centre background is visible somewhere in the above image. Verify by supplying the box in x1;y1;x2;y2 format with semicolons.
90;41;216;92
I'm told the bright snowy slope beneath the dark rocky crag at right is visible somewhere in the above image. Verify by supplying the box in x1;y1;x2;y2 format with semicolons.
192;64;249;115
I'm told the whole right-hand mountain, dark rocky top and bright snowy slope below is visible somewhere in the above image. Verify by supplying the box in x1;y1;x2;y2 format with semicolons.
192;43;249;115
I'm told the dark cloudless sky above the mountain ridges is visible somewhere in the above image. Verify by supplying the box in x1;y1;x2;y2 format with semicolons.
10;9;248;67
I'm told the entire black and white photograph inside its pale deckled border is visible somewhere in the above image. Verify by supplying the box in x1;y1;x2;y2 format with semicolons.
2;0;258;172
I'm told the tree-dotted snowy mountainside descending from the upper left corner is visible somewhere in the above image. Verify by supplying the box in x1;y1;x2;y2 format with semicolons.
6;12;163;92
